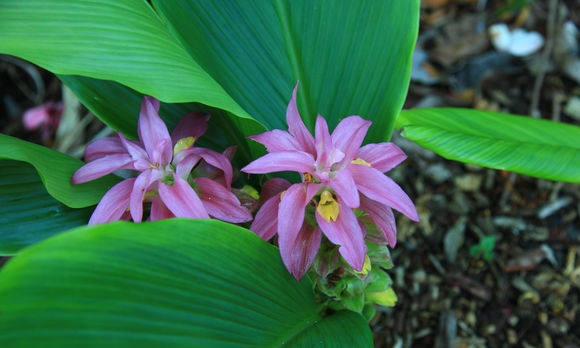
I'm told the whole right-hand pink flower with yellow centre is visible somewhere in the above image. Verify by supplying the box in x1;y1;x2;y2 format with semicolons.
242;85;418;279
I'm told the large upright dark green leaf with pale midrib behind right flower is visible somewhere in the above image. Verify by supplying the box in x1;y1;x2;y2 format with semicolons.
153;0;419;141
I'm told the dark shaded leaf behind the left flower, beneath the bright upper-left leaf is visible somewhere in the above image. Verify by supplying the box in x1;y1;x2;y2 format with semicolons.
59;75;265;165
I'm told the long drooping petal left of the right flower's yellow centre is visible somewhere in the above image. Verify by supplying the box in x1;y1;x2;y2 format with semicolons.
278;183;308;271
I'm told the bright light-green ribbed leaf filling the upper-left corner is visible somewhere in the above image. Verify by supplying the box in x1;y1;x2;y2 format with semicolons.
0;0;254;121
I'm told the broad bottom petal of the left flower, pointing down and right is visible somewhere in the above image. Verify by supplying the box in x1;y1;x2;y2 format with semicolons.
159;173;209;219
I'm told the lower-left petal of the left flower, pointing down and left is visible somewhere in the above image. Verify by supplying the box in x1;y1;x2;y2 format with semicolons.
89;178;135;225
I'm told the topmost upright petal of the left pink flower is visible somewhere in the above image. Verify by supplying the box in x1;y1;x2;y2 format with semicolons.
137;96;173;165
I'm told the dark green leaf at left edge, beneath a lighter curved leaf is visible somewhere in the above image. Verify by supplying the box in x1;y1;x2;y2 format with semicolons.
0;160;92;255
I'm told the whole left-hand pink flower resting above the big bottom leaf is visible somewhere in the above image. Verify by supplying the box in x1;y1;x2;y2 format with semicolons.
71;96;252;224
